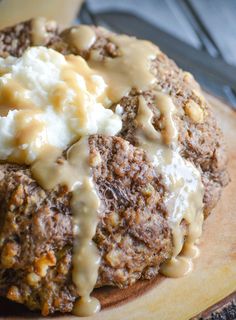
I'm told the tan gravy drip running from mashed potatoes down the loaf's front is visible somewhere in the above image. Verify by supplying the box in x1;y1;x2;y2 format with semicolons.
31;137;100;316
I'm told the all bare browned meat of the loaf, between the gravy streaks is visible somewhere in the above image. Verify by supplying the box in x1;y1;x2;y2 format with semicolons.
0;22;228;315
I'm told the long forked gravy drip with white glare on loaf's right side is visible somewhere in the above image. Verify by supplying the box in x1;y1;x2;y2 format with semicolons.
136;93;203;277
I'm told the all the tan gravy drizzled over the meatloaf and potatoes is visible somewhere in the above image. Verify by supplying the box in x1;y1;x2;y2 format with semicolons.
0;24;203;316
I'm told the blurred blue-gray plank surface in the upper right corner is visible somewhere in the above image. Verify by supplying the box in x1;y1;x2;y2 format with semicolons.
87;0;236;65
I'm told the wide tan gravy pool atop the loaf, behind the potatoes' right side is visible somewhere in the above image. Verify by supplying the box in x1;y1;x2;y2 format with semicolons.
88;31;159;102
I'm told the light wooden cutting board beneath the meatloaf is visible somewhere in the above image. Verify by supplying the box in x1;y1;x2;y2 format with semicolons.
0;94;236;320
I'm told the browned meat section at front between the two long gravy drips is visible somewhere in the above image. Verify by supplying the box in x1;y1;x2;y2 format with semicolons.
90;137;170;287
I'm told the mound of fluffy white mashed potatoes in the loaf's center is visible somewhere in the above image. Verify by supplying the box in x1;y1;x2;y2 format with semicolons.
0;47;122;163
